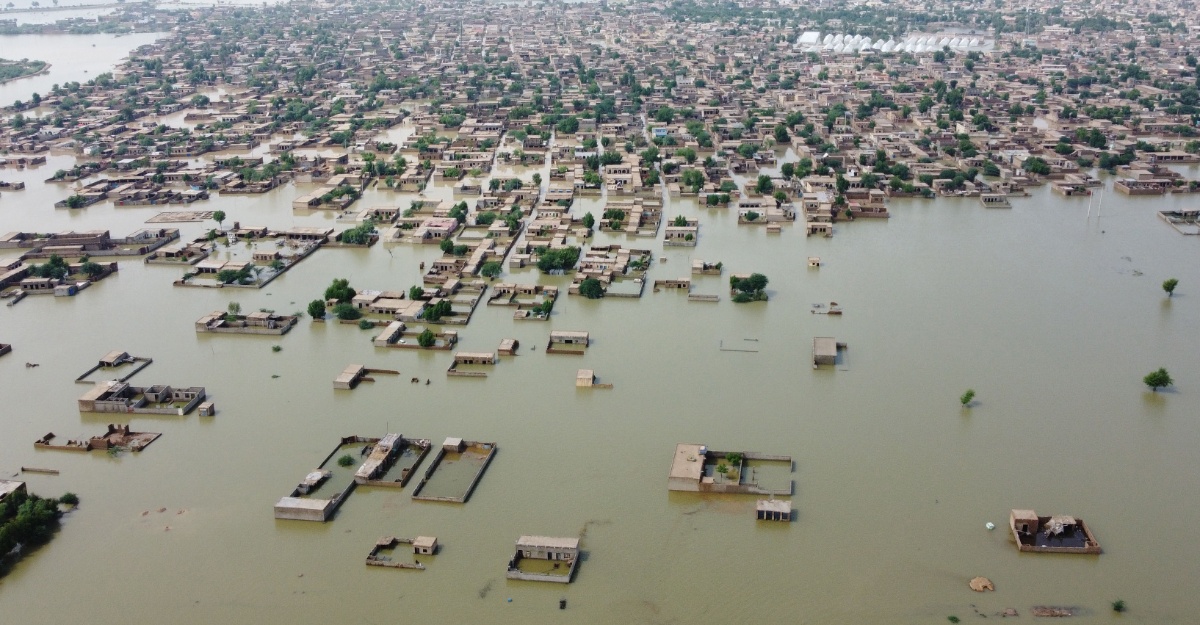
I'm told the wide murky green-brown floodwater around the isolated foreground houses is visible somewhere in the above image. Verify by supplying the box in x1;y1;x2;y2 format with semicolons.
0;47;1200;625
